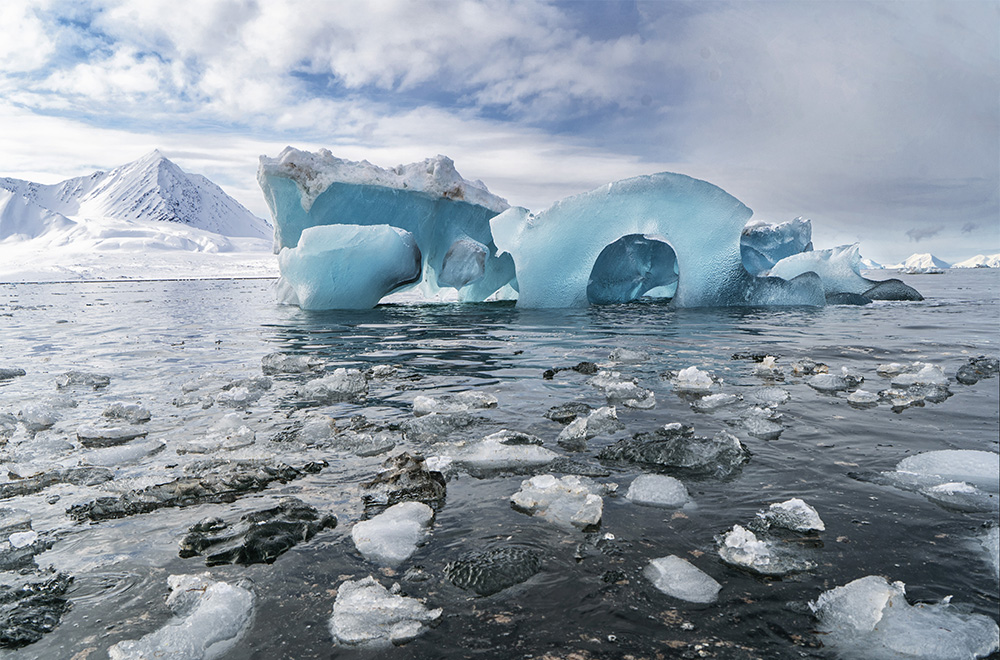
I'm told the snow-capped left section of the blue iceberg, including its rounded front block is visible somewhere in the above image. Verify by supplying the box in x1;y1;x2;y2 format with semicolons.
257;147;514;309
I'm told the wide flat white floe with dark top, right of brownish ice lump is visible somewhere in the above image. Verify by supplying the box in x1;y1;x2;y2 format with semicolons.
448;429;559;477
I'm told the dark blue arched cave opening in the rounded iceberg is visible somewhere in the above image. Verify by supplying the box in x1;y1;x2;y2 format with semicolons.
587;234;679;305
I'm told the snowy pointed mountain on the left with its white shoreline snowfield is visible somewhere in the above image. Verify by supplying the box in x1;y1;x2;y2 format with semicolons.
0;151;277;281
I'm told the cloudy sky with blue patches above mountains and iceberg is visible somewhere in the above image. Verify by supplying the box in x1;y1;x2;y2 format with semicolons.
0;0;1000;263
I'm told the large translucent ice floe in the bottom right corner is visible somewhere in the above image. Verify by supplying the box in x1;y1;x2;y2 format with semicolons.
809;575;1000;660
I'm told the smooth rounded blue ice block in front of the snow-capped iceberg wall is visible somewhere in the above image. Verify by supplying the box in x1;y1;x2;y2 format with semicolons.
278;224;421;310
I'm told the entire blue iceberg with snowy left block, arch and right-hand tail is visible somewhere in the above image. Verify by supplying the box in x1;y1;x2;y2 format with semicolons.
258;147;919;309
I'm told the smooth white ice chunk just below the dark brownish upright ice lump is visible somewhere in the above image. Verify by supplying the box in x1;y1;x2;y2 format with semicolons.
351;502;434;567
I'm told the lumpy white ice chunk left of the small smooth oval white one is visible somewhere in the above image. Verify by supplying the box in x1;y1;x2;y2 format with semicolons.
510;474;604;529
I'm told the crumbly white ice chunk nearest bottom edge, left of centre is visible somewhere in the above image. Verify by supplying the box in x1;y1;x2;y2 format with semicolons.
330;575;443;647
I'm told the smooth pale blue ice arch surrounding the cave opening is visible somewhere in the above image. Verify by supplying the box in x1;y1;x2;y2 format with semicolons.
490;172;825;307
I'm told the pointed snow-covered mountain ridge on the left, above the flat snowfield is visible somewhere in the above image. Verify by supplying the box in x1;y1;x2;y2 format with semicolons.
0;150;272;238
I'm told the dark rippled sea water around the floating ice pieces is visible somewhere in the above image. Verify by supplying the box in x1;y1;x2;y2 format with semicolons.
0;269;1000;659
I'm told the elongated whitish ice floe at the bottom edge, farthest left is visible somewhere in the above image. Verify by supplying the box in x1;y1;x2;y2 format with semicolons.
108;573;255;660
